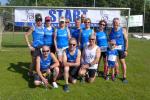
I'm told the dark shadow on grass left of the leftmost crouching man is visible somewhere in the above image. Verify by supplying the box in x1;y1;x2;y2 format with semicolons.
8;62;35;88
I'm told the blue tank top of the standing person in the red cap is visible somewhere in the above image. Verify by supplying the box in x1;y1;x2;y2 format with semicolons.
44;27;54;46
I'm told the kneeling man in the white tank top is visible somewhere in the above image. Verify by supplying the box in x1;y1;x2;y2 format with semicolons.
79;35;101;83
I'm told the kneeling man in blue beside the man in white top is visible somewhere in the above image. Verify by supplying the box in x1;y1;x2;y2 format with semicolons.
63;38;81;92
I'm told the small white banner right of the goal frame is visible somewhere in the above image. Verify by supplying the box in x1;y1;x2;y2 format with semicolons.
129;15;143;27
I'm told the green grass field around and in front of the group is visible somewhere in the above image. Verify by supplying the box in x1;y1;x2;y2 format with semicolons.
0;34;150;100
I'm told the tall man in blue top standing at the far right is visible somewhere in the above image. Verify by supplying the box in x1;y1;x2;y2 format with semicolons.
109;18;128;83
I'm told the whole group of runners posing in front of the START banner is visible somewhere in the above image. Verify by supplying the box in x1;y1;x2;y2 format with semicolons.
25;14;128;92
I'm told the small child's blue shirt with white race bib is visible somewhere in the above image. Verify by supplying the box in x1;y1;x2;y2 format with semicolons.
107;49;118;67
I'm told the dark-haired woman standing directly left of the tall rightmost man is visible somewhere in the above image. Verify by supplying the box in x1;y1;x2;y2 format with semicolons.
96;20;108;77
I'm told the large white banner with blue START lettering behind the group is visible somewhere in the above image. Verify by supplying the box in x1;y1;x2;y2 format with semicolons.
15;8;120;26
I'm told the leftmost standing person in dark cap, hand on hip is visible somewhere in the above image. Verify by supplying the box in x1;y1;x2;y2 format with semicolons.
25;13;44;76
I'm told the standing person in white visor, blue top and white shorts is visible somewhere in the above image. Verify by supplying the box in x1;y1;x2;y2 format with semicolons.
54;17;70;78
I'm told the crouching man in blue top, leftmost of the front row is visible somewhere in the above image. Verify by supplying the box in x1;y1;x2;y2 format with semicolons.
34;46;59;88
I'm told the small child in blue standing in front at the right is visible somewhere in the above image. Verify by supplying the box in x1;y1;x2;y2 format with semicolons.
105;40;118;81
